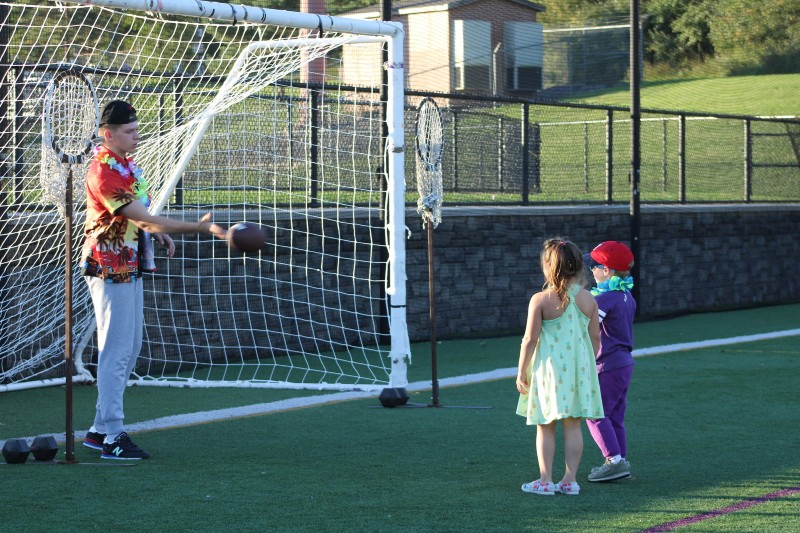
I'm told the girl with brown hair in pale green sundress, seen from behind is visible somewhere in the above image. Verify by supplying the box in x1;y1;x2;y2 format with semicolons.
517;238;603;496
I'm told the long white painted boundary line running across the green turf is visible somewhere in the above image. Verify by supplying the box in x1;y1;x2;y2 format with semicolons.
0;329;800;446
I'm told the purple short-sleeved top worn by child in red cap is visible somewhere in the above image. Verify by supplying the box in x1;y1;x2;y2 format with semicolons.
595;290;636;372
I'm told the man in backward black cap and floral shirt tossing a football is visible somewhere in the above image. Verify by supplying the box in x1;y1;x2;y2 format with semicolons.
81;100;226;459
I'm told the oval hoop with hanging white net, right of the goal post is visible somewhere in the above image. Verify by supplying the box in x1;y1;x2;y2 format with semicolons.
416;98;444;228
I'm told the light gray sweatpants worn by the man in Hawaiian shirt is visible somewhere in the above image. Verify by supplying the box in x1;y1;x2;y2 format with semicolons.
86;276;144;439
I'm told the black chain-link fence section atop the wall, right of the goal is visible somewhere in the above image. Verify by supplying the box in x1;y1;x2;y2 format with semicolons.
406;93;800;205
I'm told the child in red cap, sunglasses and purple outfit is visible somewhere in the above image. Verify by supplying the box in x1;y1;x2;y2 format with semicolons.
584;241;636;482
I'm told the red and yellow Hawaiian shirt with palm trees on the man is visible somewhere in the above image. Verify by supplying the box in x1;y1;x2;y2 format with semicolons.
81;146;149;283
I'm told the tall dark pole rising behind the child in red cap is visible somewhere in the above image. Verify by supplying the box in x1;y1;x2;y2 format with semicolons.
630;0;641;313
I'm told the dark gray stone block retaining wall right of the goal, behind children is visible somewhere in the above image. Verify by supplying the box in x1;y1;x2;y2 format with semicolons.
407;204;800;340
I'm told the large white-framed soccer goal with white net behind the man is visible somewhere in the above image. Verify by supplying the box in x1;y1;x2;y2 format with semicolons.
0;0;410;391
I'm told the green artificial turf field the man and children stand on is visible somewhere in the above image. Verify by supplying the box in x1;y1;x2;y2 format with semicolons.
0;305;800;532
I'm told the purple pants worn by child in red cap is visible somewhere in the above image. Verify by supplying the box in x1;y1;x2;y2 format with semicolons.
586;365;633;458
